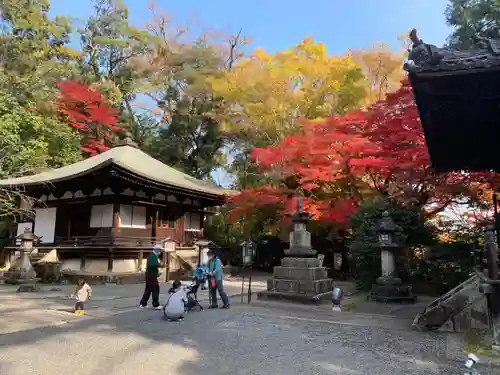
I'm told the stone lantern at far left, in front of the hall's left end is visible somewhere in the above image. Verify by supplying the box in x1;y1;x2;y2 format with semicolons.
6;228;40;291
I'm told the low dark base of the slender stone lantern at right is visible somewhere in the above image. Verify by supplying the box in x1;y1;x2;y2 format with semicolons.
368;276;417;303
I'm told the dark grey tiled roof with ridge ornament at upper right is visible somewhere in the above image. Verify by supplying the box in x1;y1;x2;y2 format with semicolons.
404;30;500;74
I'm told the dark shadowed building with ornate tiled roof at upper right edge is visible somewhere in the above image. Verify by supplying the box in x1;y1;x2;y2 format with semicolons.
405;30;500;172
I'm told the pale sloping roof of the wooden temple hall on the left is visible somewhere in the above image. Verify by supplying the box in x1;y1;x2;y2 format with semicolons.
0;145;233;196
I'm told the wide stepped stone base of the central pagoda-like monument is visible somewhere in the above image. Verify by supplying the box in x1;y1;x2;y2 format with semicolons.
258;257;332;304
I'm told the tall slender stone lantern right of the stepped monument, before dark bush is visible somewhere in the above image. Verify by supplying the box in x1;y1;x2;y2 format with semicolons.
369;211;416;302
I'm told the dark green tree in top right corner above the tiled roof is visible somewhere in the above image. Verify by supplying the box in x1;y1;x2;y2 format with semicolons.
445;0;500;48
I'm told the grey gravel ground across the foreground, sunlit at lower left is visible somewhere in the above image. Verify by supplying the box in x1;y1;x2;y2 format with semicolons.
0;305;498;375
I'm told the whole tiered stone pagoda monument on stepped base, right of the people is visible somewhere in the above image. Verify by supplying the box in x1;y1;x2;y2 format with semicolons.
258;197;332;303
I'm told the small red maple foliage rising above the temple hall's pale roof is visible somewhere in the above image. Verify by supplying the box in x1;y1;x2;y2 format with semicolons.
57;81;123;156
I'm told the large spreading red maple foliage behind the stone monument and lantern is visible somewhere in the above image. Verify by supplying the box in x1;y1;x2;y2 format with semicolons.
230;82;492;223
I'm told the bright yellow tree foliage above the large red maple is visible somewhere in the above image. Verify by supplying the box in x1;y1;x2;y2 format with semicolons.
210;37;365;143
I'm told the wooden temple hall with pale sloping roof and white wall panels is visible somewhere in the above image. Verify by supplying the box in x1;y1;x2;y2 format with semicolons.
0;143;230;274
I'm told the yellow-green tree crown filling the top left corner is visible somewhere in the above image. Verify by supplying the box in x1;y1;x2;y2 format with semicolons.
0;0;78;112
